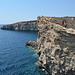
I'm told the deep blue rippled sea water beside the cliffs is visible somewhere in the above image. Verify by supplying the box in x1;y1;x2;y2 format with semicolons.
0;25;45;75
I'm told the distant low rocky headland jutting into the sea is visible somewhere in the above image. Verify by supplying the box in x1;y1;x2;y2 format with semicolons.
1;20;38;31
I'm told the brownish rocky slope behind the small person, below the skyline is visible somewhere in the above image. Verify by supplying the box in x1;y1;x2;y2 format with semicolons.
37;16;75;29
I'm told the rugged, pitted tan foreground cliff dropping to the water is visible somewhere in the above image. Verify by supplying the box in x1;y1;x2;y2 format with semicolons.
25;17;75;75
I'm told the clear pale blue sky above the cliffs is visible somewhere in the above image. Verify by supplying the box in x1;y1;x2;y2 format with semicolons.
0;0;75;24
